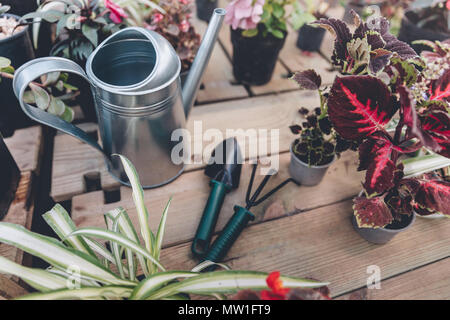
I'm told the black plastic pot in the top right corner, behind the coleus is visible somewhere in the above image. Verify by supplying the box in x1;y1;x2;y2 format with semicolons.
398;11;450;53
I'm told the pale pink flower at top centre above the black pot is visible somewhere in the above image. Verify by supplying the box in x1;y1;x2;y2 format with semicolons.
225;0;265;30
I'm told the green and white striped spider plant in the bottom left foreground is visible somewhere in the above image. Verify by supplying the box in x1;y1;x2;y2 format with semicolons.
0;156;327;299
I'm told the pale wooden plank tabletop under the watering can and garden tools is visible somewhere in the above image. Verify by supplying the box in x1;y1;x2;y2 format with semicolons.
44;1;450;300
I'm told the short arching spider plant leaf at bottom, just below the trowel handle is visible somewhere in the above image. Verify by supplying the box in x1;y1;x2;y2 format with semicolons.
130;271;198;300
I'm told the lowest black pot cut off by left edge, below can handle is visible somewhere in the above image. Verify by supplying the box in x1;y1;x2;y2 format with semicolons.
0;134;20;220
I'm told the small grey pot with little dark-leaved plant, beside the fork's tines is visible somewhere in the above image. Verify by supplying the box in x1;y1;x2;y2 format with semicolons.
289;144;336;186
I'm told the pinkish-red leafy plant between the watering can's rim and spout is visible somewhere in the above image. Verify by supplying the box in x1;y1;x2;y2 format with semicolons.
145;0;200;84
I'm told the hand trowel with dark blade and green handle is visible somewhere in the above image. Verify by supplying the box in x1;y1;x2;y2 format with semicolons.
191;138;242;258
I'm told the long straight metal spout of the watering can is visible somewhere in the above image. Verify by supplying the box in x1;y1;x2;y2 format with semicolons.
183;8;226;116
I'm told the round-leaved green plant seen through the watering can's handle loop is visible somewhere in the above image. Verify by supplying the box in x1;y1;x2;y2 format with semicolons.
0;57;79;122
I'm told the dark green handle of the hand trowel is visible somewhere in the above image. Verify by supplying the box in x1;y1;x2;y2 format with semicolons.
191;180;230;258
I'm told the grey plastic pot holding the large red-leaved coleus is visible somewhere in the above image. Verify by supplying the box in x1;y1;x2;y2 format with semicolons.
352;191;416;244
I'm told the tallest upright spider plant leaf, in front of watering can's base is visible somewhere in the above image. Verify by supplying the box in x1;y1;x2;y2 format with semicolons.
119;155;154;270
